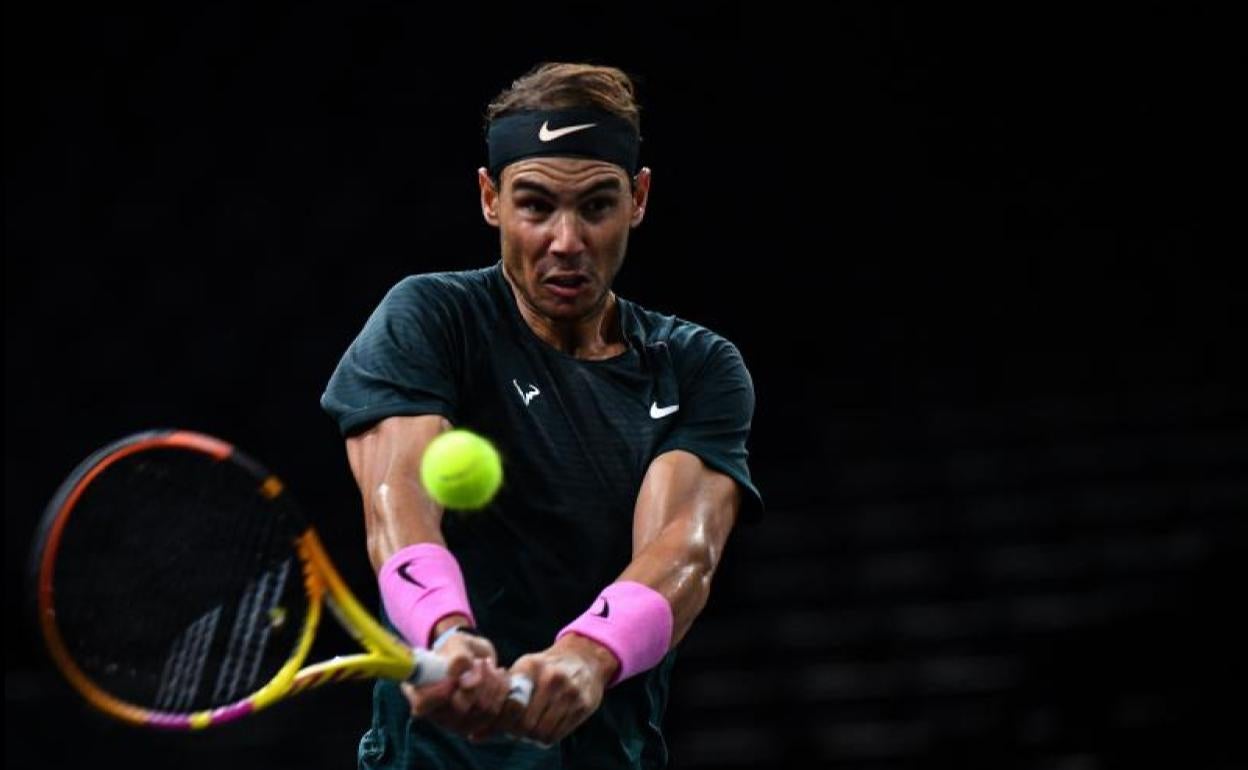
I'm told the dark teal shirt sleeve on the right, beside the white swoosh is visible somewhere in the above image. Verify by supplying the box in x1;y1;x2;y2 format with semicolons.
656;338;763;519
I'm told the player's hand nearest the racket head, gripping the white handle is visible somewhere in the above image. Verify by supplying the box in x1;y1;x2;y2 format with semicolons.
402;623;510;740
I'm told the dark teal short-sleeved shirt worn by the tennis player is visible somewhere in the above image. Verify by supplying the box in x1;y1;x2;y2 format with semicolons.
321;265;761;769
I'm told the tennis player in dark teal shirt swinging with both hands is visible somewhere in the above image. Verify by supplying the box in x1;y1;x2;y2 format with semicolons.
321;64;761;769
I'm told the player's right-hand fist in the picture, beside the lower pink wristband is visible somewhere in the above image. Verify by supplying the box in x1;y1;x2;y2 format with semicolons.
495;634;619;745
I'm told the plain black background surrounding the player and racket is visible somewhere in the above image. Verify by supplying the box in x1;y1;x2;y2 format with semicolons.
4;2;1248;769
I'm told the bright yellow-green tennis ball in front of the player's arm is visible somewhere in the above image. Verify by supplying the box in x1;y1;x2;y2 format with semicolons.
421;429;503;510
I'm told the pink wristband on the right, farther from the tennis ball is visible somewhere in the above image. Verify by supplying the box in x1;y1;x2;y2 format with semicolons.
555;580;673;685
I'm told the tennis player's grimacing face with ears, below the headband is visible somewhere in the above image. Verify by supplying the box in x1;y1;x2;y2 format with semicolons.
478;157;650;322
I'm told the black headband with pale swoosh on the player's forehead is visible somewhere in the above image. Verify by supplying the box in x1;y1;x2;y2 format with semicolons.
485;109;641;180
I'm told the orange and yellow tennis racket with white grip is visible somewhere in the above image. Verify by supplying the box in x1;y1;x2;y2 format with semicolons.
32;431;532;730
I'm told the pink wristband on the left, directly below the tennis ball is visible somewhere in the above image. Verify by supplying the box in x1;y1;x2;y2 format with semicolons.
377;543;475;649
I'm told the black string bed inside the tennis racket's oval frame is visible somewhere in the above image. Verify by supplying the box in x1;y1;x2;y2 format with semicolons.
54;449;307;713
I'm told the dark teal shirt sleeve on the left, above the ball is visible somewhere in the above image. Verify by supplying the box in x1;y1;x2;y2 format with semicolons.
321;276;463;436
